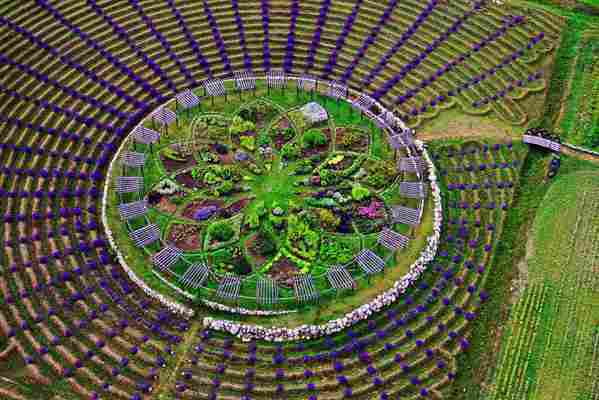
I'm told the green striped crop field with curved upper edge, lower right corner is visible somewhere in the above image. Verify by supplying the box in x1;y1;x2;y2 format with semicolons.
487;171;599;399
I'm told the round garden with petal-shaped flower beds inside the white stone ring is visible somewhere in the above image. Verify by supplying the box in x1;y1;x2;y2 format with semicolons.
107;86;431;310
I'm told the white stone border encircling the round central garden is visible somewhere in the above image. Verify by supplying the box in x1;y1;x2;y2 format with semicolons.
102;76;443;341
